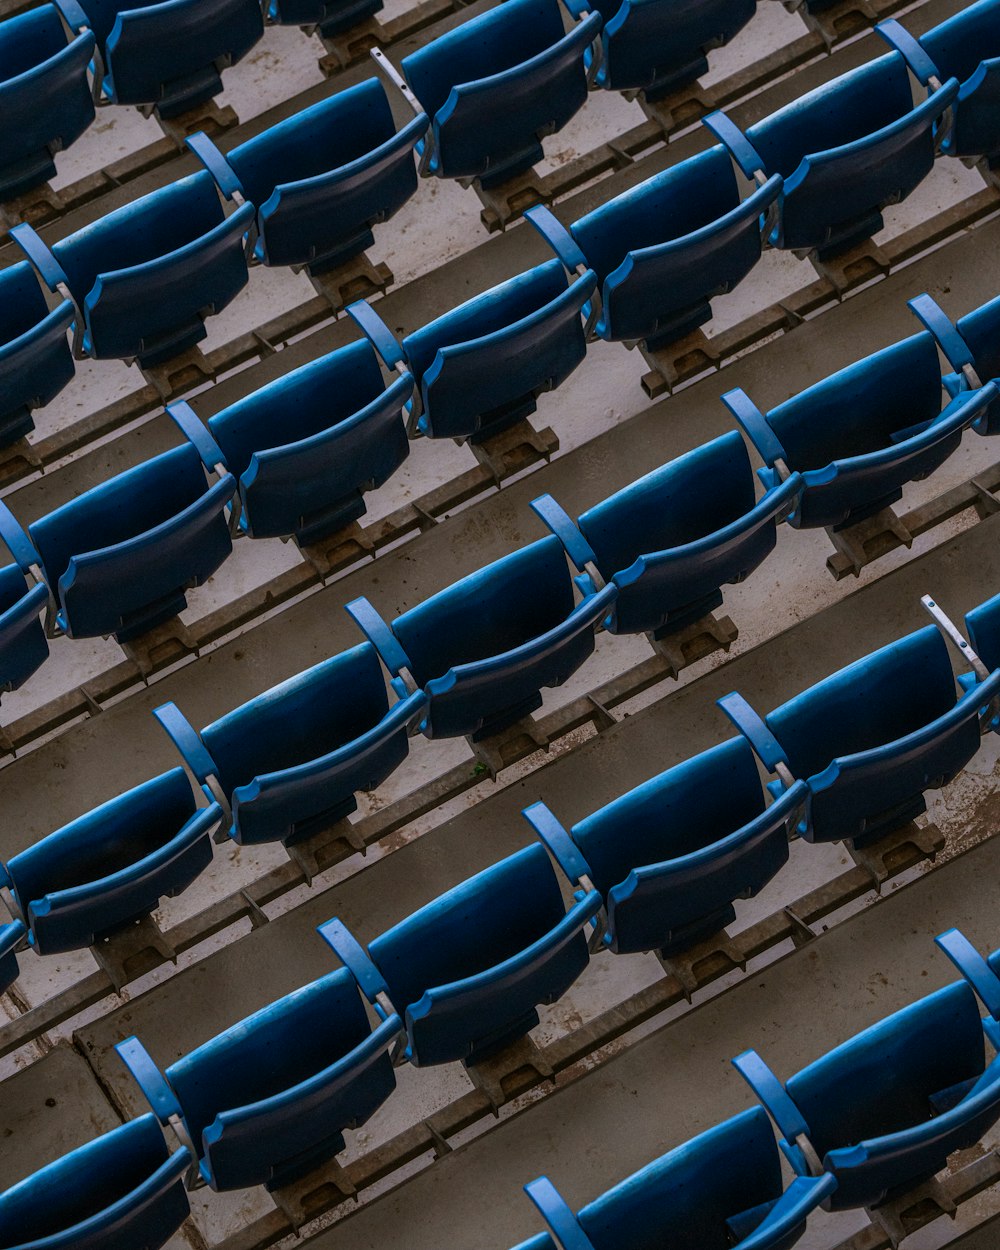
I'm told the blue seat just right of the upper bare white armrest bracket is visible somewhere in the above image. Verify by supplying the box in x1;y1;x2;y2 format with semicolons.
403;0;600;185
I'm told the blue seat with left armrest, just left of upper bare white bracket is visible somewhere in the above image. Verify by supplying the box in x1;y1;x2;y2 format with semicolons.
188;79;429;274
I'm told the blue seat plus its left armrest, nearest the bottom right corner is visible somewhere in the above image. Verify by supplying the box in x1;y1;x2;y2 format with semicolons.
733;950;1000;1211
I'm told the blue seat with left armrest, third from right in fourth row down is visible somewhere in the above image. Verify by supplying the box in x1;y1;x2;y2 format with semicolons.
531;430;803;639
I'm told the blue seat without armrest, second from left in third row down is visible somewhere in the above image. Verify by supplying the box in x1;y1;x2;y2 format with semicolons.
30;443;235;641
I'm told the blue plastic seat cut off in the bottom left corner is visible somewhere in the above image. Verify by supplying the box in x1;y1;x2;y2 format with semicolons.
0;1115;191;1250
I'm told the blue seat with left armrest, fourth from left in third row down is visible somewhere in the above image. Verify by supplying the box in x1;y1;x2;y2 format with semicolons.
348;258;598;443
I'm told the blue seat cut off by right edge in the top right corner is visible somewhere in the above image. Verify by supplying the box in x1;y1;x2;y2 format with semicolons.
920;0;1000;160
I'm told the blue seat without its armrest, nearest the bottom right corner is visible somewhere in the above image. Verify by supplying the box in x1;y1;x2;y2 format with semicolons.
786;981;1000;1210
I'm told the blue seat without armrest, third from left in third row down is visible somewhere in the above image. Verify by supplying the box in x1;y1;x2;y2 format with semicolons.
208;341;414;544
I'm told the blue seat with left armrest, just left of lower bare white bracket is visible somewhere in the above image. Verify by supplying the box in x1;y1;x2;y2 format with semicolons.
719;625;1000;845
